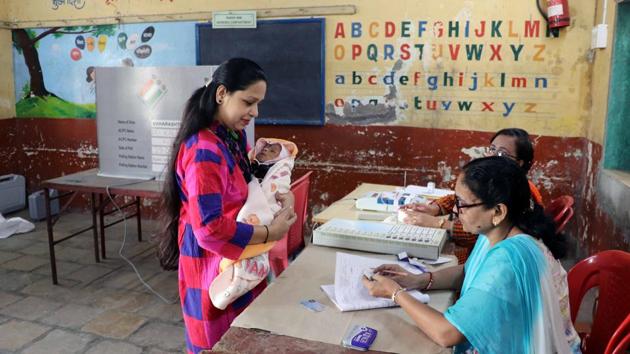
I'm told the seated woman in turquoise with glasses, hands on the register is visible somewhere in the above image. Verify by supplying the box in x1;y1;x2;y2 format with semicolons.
363;157;580;354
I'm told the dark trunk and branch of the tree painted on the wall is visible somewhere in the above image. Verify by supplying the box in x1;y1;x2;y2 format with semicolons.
13;25;116;97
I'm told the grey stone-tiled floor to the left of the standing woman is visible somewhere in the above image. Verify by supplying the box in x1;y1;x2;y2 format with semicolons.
0;212;184;354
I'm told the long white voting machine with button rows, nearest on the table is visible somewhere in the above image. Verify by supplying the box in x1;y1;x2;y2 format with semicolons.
313;219;446;260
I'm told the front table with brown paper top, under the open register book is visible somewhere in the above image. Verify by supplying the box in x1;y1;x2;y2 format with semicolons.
213;245;457;354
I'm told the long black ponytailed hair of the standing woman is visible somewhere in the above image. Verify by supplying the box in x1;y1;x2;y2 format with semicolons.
157;58;267;270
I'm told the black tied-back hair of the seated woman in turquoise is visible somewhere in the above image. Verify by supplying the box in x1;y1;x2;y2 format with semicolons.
462;156;566;258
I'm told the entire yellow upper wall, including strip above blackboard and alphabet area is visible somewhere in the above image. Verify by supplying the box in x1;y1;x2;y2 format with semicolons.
0;0;615;142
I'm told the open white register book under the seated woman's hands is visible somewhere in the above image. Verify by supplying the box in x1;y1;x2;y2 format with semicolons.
321;252;429;312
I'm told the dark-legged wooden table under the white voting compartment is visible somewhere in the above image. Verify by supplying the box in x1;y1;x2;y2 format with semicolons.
42;169;162;284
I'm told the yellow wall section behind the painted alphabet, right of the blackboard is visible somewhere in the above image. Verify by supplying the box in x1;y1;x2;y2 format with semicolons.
327;0;595;136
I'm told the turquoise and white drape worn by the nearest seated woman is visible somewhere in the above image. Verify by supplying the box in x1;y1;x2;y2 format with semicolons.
444;234;579;354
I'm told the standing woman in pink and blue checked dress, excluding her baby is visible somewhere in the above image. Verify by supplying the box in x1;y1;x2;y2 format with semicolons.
158;58;296;353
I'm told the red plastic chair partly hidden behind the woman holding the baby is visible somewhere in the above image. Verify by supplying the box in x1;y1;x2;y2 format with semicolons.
269;171;313;276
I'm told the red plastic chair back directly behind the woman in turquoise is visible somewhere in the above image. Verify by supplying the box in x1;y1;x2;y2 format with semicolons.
568;250;630;354
